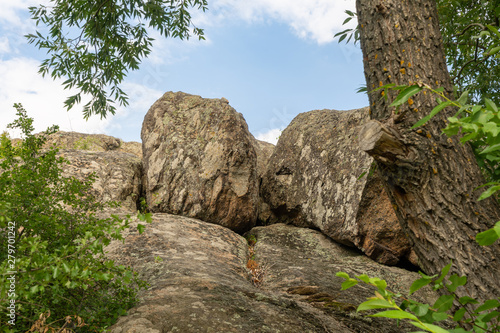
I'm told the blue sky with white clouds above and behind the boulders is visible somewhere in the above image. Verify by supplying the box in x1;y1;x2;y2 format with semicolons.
0;0;368;142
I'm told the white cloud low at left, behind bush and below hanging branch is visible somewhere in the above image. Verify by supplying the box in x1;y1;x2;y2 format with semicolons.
0;58;112;136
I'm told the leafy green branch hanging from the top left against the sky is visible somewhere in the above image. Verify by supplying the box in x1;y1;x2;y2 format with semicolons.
26;0;207;118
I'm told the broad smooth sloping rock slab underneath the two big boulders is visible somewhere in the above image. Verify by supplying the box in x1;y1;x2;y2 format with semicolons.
107;214;435;333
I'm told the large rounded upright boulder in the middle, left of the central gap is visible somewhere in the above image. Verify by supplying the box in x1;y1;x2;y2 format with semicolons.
141;92;258;232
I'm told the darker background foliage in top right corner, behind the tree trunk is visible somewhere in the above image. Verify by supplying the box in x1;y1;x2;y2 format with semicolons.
437;0;500;104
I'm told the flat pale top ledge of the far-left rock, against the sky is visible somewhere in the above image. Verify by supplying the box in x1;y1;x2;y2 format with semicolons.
45;131;142;158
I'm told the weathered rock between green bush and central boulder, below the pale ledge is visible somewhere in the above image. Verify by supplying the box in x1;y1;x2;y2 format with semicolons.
59;150;142;212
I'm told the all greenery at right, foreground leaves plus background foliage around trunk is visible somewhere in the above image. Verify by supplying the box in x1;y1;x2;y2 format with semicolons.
337;9;500;333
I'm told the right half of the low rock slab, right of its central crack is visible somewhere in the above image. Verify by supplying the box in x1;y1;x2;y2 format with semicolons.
247;224;439;333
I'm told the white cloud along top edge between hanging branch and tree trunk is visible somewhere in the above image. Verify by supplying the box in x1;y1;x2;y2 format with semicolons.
205;0;356;44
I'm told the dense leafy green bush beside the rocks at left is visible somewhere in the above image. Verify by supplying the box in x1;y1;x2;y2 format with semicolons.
0;105;149;332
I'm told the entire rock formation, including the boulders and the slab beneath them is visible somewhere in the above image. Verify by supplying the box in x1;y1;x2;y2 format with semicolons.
11;93;428;333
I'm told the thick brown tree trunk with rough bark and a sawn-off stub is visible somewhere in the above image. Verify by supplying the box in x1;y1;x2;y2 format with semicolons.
356;0;500;300
